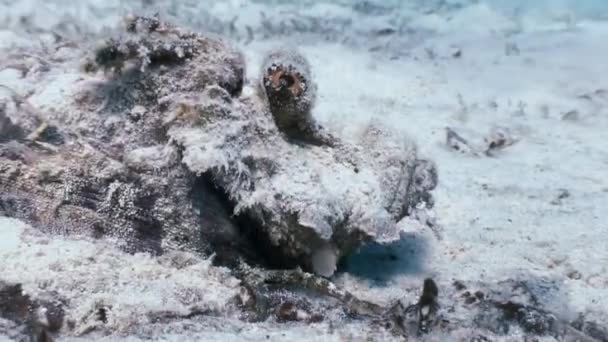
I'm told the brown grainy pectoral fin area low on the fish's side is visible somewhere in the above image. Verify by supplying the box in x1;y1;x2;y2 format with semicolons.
0;143;207;254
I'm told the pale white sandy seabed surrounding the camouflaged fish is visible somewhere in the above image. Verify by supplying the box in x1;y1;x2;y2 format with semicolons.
0;0;608;341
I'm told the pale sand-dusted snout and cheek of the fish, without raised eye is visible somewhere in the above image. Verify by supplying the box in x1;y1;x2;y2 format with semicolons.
168;80;436;275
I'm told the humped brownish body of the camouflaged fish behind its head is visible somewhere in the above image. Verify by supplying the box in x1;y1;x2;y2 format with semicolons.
0;17;244;254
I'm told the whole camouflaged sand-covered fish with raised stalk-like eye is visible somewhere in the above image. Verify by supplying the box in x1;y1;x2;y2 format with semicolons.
0;17;436;275
